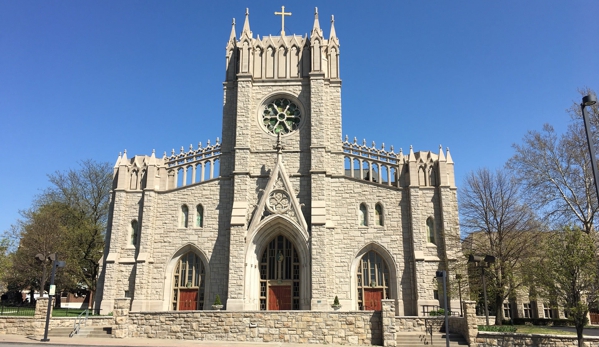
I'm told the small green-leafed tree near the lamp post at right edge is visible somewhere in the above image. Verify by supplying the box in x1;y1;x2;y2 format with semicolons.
536;228;597;347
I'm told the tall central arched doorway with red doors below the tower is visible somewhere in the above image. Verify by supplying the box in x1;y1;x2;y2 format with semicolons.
260;235;300;310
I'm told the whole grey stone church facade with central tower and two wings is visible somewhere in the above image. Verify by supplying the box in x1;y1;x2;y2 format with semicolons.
96;11;460;316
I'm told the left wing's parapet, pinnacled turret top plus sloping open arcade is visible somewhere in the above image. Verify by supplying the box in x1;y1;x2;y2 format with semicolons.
114;138;221;191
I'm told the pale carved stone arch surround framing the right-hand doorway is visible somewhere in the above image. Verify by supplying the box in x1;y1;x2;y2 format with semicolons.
349;241;400;310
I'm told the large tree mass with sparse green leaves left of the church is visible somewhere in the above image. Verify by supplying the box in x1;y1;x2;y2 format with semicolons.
3;160;113;308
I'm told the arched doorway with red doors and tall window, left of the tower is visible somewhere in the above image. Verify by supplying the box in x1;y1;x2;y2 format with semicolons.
171;251;206;311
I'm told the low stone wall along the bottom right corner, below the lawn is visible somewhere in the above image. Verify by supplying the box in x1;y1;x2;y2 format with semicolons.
471;331;599;347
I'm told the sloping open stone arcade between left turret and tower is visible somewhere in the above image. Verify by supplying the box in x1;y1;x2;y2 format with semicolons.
163;138;221;189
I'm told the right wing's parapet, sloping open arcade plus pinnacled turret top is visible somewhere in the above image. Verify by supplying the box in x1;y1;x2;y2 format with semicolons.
342;136;455;188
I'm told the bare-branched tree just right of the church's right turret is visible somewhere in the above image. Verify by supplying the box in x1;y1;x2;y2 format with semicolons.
460;168;539;324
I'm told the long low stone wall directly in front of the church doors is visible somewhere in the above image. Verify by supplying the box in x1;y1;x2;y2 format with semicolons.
127;311;383;345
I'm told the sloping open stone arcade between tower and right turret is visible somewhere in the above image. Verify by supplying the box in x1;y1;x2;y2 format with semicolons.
343;136;404;187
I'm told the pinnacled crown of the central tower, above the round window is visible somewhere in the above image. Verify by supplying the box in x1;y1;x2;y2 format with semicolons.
226;9;339;81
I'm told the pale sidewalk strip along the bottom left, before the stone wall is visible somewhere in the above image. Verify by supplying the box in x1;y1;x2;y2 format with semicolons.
0;334;347;347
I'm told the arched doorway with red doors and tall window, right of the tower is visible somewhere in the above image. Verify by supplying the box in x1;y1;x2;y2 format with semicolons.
356;250;389;311
